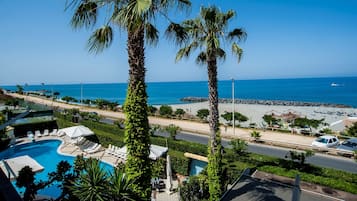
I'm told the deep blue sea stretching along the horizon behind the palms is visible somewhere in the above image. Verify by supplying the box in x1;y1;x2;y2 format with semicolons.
0;77;357;107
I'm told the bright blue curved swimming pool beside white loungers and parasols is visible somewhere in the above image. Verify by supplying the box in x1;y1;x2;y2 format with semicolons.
0;140;113;198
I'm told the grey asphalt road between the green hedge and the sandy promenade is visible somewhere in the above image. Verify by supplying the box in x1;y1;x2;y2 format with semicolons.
157;132;357;174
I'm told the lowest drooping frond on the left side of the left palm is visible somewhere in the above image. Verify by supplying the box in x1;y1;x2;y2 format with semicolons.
88;25;113;53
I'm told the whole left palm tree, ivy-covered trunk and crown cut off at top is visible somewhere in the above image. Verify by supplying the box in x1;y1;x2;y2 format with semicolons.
67;0;190;199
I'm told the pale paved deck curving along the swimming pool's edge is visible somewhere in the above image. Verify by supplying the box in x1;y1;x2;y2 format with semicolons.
17;135;179;201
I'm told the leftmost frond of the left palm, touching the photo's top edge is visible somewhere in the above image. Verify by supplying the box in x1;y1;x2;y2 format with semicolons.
71;1;98;29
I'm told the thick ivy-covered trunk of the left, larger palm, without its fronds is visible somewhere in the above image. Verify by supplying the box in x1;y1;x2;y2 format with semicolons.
124;26;151;200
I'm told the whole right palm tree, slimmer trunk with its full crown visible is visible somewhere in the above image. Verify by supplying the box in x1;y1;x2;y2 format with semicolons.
166;6;246;200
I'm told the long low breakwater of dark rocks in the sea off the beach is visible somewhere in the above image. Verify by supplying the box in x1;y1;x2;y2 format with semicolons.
180;97;352;108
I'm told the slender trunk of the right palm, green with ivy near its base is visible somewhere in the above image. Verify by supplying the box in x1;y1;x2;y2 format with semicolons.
207;56;222;201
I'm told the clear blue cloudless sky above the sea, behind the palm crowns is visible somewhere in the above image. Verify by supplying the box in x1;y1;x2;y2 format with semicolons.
0;0;357;85
